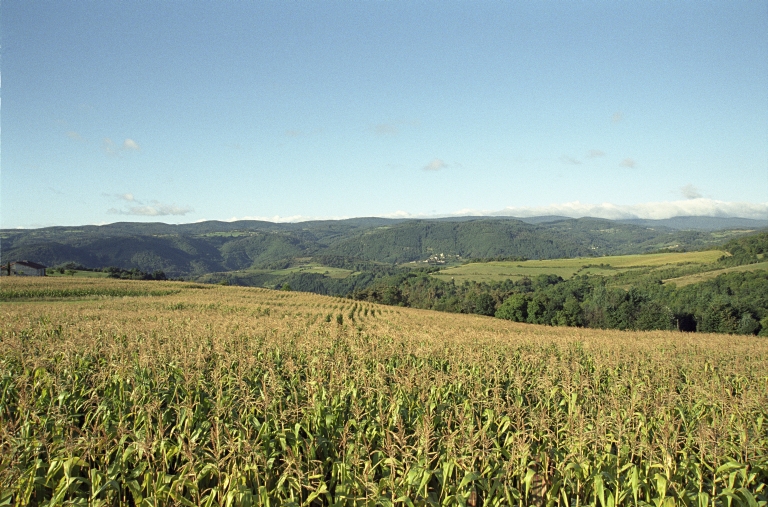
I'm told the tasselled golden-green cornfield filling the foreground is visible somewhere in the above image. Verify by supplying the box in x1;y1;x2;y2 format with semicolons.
0;278;768;507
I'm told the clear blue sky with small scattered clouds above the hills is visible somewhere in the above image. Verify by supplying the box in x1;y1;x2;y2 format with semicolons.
0;0;768;228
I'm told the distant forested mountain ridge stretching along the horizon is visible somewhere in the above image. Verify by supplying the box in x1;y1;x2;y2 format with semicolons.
0;217;768;278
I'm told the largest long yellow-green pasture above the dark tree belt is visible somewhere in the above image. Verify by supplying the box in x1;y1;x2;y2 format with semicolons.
433;250;725;282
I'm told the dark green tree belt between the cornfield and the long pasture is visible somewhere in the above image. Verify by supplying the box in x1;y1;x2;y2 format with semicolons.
352;233;768;336
